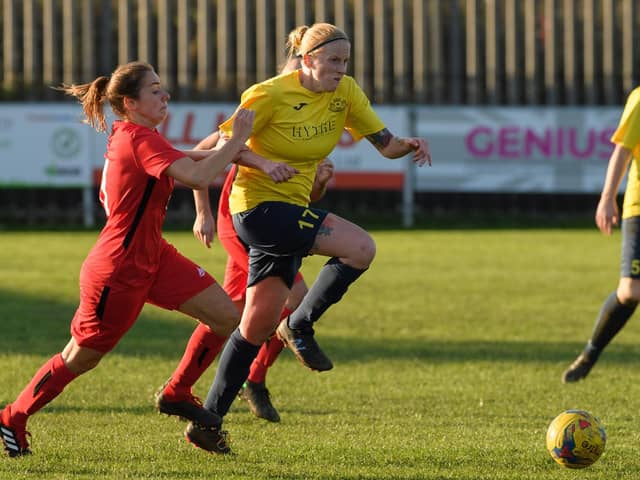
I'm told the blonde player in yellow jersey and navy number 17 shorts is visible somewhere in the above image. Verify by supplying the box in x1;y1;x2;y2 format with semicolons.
190;23;431;452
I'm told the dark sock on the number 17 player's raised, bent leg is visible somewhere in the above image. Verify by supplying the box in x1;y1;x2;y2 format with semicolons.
289;257;365;329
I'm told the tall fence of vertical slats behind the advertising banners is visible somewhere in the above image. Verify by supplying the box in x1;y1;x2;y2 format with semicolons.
0;0;640;105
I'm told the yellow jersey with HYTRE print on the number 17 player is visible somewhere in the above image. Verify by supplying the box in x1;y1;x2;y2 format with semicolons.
220;71;385;213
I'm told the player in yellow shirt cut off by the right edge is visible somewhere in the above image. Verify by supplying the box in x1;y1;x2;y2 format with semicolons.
562;83;640;383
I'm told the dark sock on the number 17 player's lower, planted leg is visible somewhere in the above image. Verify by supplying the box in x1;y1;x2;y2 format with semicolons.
204;329;260;417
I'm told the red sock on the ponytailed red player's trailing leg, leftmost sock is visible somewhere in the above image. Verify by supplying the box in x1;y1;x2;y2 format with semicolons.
11;353;78;422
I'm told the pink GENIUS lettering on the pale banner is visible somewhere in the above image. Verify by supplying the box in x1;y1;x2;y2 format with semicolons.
465;126;614;160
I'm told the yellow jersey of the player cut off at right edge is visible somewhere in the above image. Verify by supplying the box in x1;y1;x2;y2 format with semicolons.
611;87;640;218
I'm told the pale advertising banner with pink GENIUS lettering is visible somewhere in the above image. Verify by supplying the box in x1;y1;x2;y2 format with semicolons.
415;107;624;193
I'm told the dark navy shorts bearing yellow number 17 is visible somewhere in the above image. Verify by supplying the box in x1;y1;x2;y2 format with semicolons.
233;202;328;288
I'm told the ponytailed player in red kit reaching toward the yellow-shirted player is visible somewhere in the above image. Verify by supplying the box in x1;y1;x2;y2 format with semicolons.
0;62;255;457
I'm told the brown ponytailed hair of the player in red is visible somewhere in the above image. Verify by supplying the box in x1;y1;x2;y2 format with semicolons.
58;62;154;132
